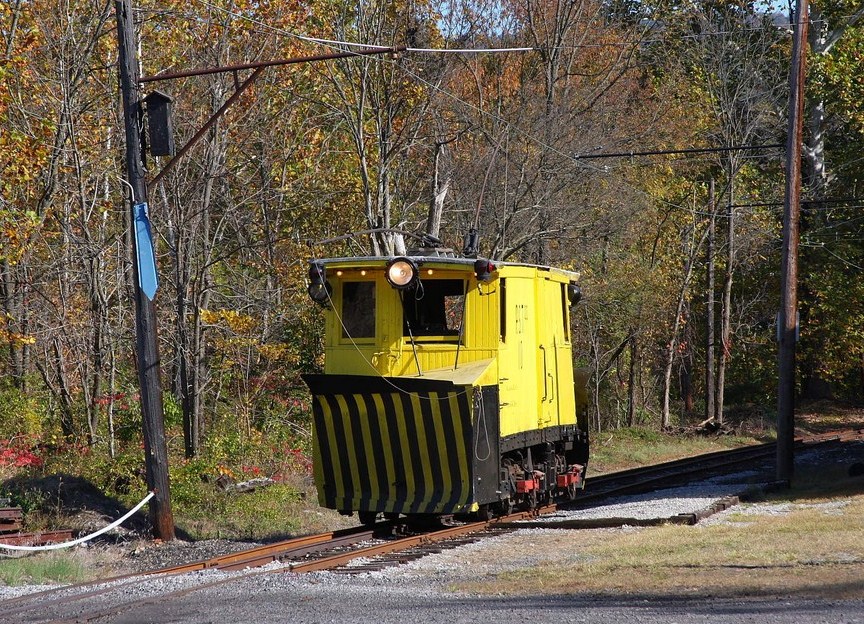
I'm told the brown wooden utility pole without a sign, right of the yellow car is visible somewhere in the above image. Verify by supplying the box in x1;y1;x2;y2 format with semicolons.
777;0;809;482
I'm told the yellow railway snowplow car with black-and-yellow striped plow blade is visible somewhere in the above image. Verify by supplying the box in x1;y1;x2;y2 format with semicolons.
304;256;588;523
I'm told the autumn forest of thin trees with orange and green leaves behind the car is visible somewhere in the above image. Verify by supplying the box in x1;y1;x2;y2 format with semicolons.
0;0;864;532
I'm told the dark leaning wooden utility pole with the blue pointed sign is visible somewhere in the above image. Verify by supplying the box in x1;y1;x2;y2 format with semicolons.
114;0;174;540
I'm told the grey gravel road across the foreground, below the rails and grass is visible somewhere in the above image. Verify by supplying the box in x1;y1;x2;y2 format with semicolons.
111;568;864;624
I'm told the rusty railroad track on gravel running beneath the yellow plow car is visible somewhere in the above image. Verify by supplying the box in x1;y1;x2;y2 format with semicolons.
6;430;864;624
